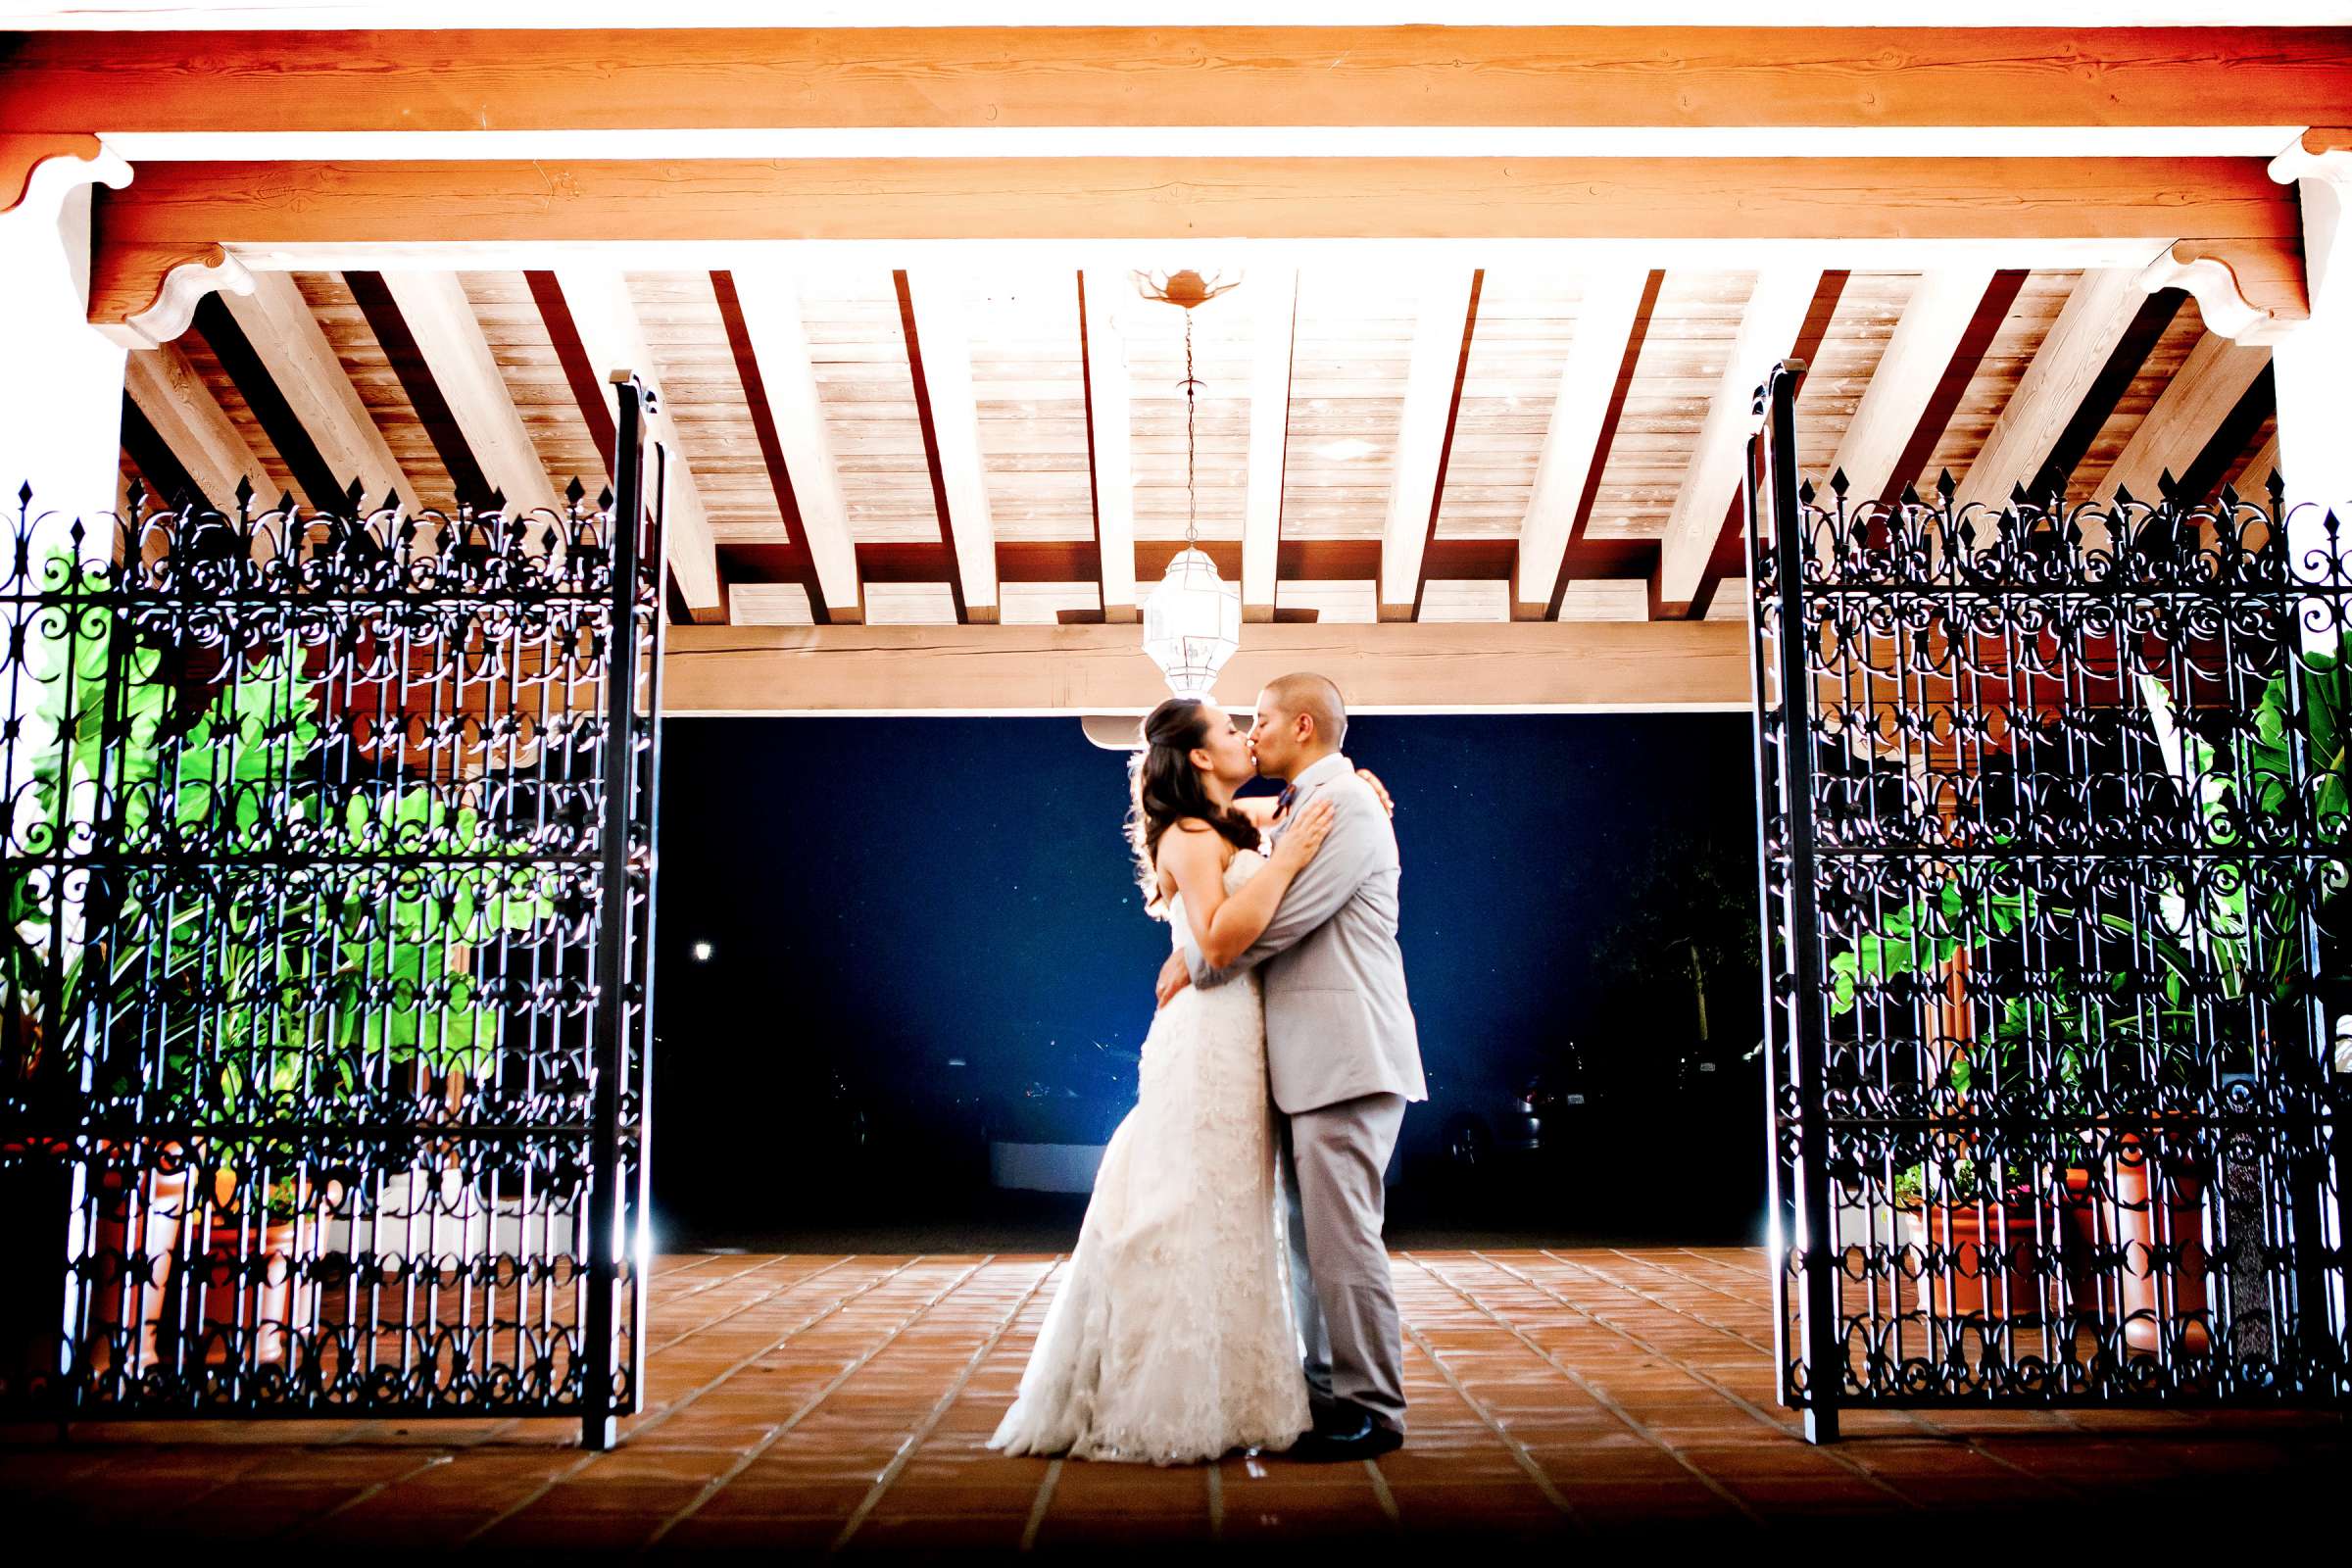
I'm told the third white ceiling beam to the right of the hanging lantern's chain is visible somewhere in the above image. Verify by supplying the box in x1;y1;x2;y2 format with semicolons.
1512;268;1648;620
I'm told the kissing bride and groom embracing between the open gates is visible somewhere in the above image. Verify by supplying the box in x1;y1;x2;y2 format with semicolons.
988;674;1428;1464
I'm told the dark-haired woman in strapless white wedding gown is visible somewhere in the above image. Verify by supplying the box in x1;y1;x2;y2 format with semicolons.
988;698;1331;1464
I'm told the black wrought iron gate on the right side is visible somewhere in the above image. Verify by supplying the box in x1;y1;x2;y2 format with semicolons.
1747;365;2352;1441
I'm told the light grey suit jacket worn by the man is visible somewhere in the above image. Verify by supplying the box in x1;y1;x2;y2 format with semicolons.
1186;755;1430;1114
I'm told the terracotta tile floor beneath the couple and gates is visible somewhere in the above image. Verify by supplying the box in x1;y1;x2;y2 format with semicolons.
0;1249;2352;1561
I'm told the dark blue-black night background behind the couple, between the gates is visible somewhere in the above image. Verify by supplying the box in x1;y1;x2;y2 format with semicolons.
652;714;1764;1249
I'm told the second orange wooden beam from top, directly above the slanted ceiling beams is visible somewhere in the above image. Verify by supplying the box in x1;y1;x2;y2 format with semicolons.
92;158;2300;322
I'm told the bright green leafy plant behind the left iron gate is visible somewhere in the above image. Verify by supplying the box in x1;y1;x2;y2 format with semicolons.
0;564;553;1210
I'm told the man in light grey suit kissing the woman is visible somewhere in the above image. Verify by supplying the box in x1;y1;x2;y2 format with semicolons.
1159;674;1428;1462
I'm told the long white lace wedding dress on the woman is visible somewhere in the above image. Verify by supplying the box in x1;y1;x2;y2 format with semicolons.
988;854;1310;1464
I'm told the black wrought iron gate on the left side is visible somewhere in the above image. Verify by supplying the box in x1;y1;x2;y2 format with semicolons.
0;378;663;1444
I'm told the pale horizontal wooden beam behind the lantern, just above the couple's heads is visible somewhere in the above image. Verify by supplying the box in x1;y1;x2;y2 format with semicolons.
663;620;1752;714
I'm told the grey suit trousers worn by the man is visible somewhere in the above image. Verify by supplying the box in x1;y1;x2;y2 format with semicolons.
1282;1093;1404;1432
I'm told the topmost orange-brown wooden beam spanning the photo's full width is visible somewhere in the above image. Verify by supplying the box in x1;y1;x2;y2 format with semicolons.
0;27;2352;145
